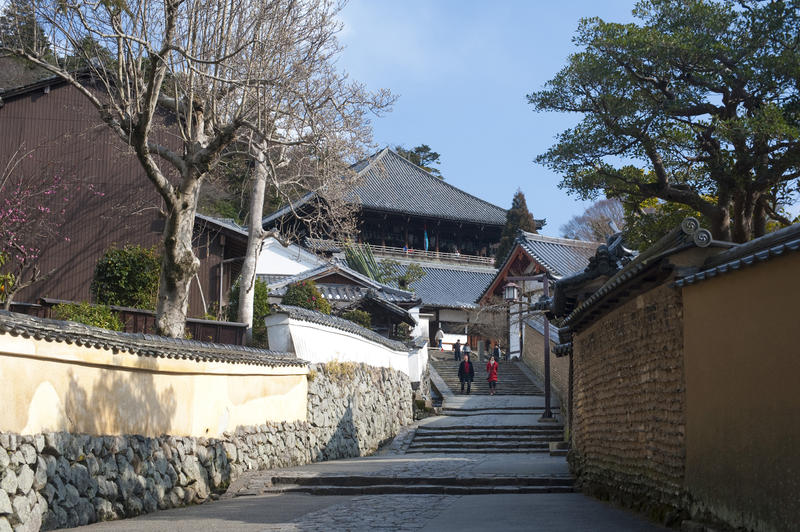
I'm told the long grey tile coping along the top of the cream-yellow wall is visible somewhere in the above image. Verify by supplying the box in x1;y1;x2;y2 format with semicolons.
0;311;307;367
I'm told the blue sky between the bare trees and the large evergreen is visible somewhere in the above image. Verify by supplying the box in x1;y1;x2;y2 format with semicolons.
339;0;634;236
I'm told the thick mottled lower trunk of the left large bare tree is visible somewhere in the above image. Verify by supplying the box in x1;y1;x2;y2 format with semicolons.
156;189;200;338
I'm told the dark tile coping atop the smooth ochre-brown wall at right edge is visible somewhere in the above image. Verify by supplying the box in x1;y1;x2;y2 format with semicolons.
675;220;800;287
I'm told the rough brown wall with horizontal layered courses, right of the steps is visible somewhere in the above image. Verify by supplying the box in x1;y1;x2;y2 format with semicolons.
570;285;685;521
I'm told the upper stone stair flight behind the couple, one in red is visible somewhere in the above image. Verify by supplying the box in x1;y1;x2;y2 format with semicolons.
429;350;544;395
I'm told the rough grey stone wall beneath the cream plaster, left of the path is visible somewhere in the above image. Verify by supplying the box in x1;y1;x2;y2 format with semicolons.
0;363;412;532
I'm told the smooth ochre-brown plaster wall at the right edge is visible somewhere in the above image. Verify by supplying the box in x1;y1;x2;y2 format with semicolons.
683;253;800;530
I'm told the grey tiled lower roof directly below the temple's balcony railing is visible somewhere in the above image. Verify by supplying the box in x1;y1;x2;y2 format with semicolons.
411;263;497;308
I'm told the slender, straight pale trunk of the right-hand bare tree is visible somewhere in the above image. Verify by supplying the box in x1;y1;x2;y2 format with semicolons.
238;144;269;344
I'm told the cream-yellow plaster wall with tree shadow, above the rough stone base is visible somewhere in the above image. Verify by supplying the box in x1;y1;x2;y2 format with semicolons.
0;334;308;437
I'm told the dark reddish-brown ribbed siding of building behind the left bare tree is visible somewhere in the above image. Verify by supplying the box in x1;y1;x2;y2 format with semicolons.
0;84;238;316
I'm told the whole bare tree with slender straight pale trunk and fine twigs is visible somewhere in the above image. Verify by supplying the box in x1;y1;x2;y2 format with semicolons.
206;2;393;336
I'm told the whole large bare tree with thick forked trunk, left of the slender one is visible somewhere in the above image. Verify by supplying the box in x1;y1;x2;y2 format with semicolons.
2;0;384;336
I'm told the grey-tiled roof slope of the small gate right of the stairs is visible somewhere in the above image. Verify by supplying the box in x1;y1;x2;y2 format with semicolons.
516;231;600;279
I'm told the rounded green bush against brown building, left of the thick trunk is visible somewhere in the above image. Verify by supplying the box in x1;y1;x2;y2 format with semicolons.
92;245;161;310
